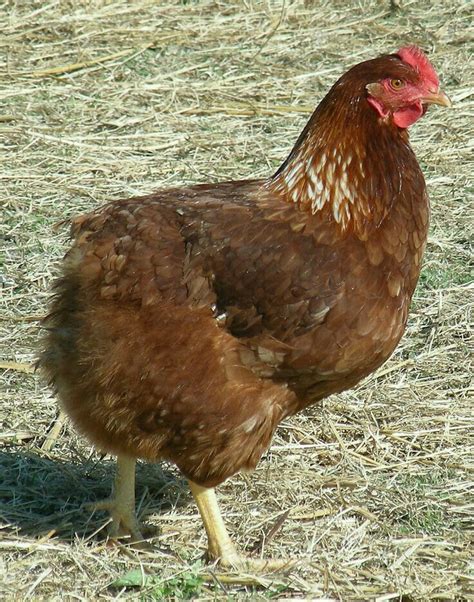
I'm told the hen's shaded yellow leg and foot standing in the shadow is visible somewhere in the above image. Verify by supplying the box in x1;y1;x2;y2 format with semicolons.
86;456;144;542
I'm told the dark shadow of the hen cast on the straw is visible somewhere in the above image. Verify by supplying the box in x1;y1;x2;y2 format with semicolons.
0;447;191;542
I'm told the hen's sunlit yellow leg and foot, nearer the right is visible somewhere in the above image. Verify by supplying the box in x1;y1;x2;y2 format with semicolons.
188;481;295;571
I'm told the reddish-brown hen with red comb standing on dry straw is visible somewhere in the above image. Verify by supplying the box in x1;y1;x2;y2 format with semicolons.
40;46;450;565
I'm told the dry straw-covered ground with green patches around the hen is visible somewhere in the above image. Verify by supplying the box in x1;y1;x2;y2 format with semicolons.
0;0;474;601
